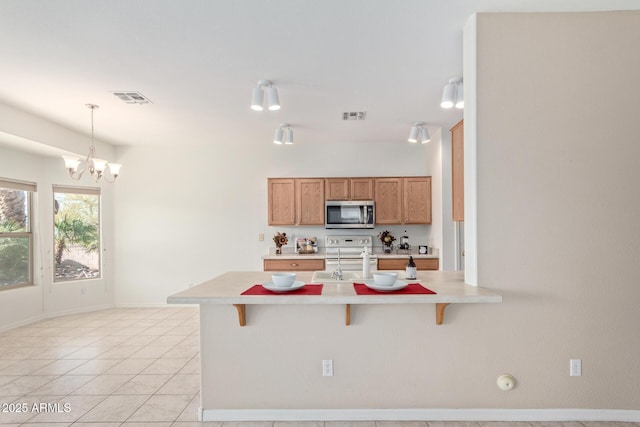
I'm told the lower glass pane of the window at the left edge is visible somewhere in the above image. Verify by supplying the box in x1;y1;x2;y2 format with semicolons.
0;235;31;289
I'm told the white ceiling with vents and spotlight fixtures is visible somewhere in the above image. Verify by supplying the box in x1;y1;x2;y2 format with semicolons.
0;0;640;151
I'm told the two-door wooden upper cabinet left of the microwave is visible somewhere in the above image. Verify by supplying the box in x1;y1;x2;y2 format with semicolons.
267;178;324;225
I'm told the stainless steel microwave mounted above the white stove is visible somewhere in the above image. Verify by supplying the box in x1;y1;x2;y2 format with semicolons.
324;200;376;228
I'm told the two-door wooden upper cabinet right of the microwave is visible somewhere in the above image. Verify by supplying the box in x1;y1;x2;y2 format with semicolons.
374;176;431;224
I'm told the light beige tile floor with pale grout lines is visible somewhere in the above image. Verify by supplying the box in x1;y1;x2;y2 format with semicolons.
0;308;640;427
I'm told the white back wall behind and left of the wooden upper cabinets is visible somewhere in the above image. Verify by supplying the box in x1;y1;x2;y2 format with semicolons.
116;142;441;306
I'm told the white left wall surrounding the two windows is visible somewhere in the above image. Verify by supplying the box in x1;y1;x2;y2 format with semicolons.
0;104;114;330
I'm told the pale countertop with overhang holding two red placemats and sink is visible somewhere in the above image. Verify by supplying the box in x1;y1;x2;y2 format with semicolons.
167;272;502;304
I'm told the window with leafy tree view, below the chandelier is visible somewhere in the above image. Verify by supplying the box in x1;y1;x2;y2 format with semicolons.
53;185;100;282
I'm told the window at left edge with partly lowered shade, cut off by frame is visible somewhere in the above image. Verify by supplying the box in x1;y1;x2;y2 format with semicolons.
0;178;36;290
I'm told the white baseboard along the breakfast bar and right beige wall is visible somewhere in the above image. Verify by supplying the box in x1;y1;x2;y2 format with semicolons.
199;409;640;422
